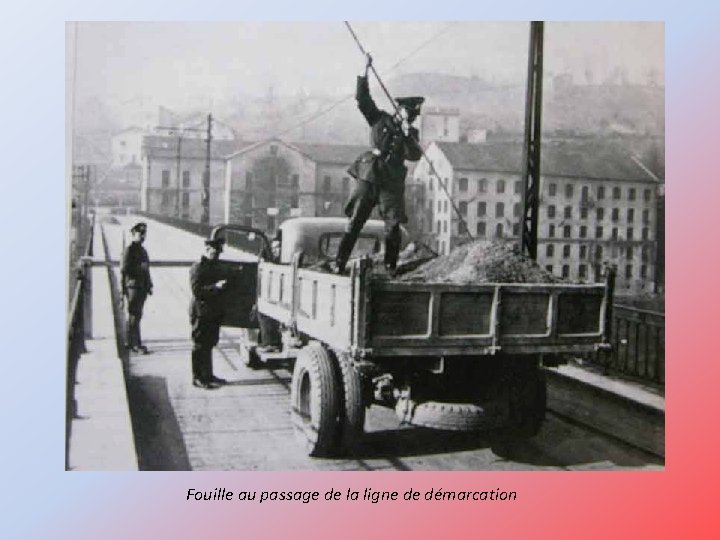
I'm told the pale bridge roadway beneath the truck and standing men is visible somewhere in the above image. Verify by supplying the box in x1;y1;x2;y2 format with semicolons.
96;216;662;471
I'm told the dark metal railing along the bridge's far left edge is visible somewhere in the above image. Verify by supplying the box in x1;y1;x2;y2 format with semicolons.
65;214;95;470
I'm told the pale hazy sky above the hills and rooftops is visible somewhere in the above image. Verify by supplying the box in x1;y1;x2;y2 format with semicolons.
67;21;665;107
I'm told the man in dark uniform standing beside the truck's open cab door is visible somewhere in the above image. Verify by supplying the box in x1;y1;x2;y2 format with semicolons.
190;239;227;390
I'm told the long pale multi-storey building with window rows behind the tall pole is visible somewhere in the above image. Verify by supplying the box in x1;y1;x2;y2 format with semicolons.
413;142;660;292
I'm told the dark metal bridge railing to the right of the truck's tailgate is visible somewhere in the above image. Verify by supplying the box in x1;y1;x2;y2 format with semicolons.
593;304;665;387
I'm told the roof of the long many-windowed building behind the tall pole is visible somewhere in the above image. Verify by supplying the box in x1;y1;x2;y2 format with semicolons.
435;141;653;181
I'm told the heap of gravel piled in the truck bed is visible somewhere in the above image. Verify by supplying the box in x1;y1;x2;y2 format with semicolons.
396;240;562;285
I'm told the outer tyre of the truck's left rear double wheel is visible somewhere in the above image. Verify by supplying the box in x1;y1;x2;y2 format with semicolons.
290;342;341;457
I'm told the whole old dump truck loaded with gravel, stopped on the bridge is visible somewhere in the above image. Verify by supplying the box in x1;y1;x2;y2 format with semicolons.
213;217;614;456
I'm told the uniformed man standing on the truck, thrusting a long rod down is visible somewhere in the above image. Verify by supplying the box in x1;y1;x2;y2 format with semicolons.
335;55;424;273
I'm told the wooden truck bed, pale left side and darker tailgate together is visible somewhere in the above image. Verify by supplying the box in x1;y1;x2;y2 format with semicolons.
258;262;611;356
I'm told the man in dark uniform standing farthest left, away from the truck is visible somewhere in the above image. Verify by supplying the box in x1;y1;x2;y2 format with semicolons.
120;223;152;354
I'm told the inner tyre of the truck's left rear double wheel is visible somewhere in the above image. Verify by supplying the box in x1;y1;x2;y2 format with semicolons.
336;353;365;454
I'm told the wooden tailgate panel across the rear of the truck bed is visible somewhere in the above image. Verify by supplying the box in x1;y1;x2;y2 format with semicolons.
361;281;606;355
